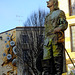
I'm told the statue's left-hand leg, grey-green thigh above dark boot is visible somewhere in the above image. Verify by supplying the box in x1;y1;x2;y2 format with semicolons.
42;41;55;75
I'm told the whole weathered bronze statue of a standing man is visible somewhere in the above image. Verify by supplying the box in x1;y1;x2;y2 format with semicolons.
42;0;68;75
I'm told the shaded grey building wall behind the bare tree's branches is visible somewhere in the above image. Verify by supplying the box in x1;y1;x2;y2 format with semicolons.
16;27;44;75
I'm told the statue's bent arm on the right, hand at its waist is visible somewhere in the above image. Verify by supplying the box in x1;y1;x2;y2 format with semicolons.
54;11;68;33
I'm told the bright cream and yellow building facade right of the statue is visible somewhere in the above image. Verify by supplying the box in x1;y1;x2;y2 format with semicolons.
58;0;75;74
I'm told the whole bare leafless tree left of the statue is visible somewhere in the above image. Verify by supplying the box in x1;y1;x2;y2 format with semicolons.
17;10;47;75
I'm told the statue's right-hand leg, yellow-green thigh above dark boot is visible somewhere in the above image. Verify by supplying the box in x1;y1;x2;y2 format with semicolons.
53;44;63;75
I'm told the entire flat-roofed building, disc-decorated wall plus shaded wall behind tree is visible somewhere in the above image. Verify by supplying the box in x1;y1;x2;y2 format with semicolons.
0;27;44;75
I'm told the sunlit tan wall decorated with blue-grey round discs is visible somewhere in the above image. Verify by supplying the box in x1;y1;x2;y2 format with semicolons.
0;29;17;75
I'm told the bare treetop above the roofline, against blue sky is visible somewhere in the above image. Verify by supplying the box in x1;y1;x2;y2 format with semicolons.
24;9;48;26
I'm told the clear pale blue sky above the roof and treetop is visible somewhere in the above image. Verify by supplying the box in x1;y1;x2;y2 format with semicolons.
0;0;49;33
